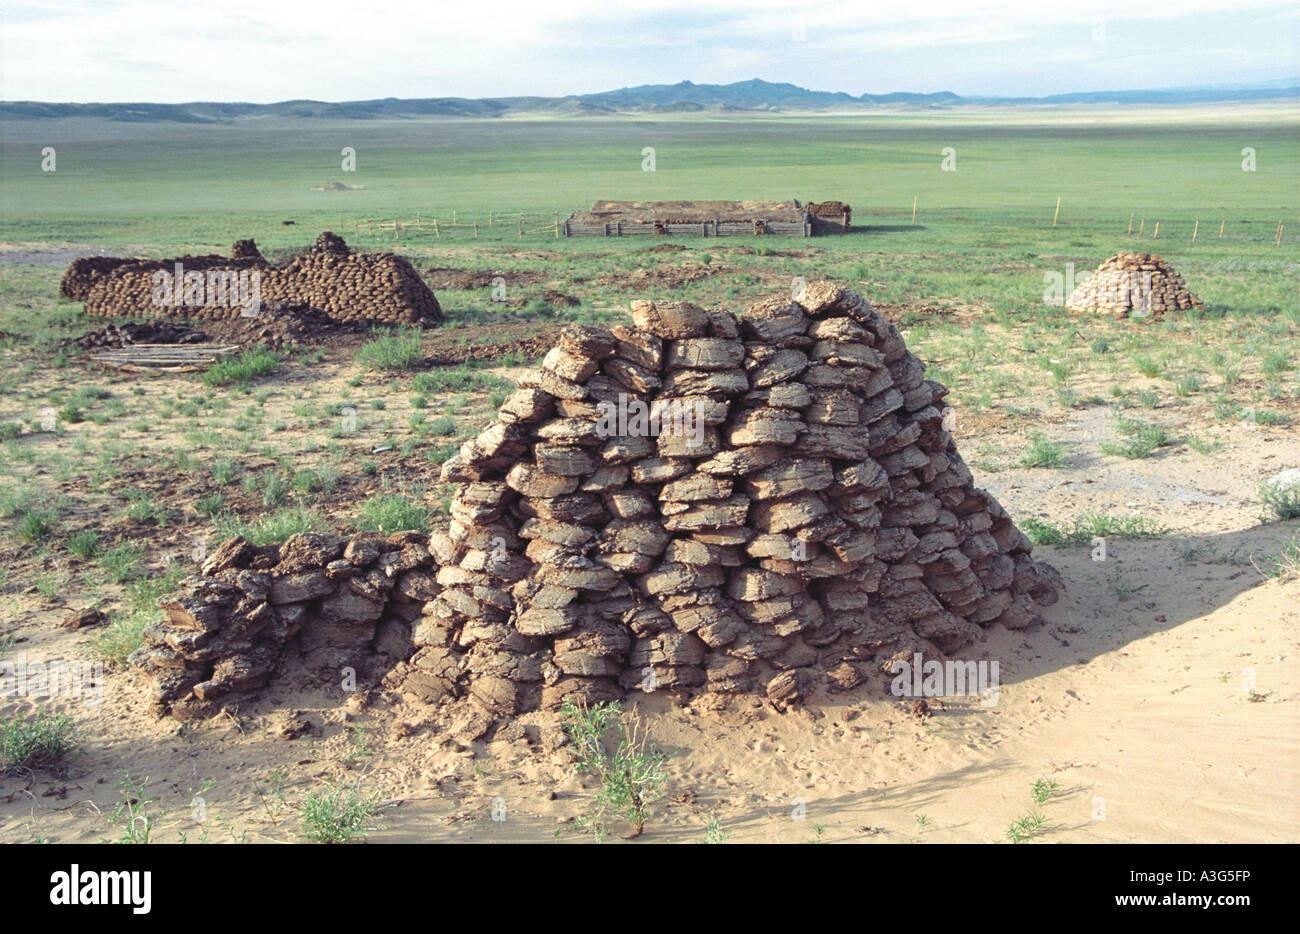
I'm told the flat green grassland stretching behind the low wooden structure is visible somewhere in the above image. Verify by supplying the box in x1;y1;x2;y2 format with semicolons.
0;105;1300;250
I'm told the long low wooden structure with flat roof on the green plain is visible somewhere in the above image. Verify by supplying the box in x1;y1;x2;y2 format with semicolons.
563;199;852;237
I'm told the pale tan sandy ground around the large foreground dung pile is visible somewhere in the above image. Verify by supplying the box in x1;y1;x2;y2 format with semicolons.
0;398;1300;843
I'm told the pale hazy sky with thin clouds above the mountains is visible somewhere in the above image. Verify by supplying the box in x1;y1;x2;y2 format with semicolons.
0;0;1300;103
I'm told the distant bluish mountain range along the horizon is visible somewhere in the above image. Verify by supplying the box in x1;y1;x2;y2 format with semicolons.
0;78;1300;124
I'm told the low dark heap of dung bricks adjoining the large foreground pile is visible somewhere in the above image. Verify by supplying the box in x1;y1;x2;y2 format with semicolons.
130;532;438;719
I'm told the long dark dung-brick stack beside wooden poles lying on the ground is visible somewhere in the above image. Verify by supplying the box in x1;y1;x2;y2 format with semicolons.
69;232;442;325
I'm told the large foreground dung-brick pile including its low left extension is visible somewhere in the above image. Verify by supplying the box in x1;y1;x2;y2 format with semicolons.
133;284;1060;717
